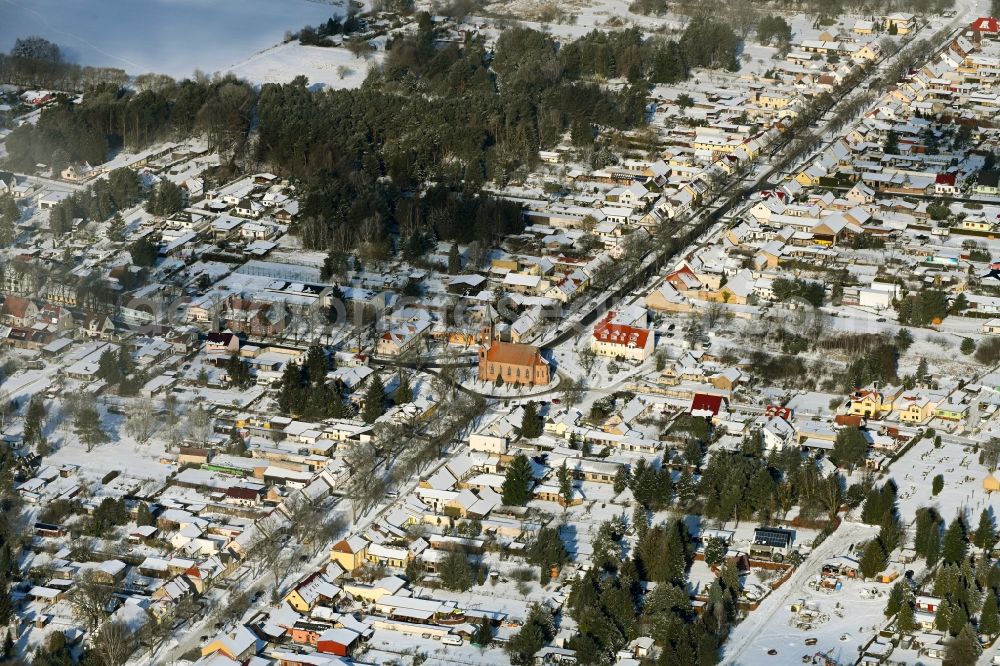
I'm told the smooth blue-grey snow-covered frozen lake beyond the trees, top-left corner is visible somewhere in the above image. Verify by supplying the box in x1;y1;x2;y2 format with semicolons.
0;0;344;79
